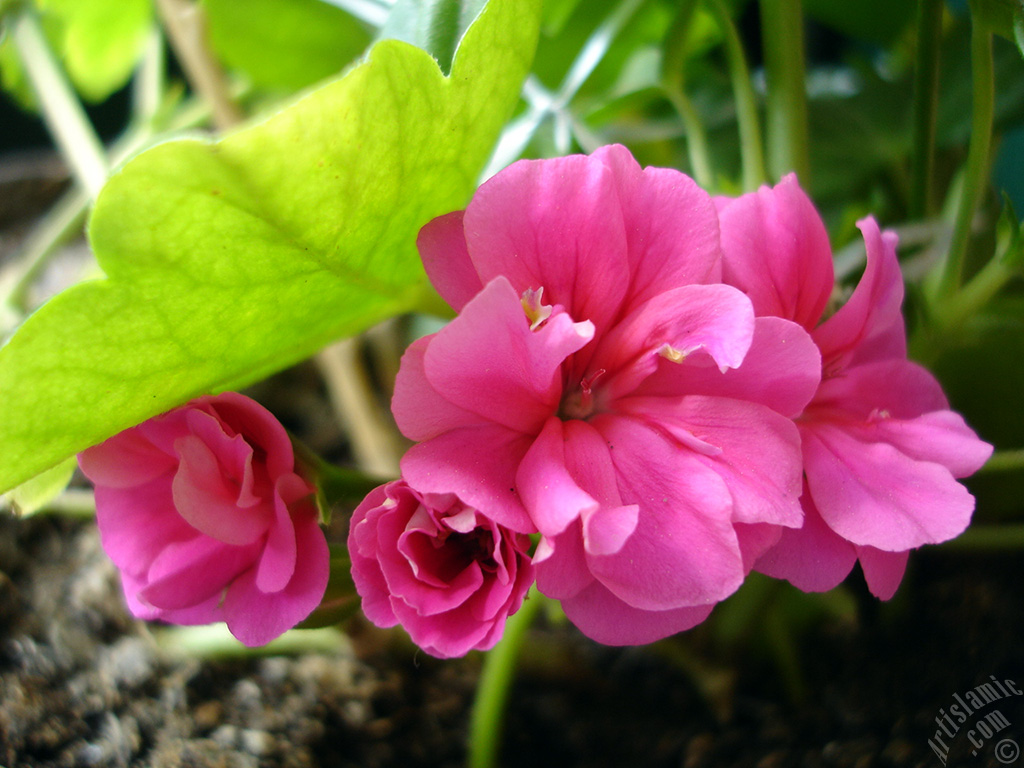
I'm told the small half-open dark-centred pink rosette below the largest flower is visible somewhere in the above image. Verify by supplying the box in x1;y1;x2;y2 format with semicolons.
348;480;534;658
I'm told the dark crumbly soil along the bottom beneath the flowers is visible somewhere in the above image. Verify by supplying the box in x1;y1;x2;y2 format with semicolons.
0;516;1024;768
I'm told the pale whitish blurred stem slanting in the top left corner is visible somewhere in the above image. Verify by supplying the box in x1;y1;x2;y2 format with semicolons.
11;7;108;200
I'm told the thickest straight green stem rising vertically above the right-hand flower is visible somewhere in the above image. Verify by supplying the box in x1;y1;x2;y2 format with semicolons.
761;0;811;187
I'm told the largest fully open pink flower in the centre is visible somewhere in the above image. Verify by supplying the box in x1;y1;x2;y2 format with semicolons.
392;146;820;644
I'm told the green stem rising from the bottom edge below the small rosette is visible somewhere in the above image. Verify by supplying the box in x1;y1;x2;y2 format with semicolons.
469;587;545;768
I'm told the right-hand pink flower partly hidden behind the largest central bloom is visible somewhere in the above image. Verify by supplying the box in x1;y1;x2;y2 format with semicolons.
718;175;992;599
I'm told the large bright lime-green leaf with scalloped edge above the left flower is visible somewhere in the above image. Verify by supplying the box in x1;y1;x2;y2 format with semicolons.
0;0;540;489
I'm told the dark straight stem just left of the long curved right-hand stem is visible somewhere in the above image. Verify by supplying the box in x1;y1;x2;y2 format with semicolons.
910;0;943;219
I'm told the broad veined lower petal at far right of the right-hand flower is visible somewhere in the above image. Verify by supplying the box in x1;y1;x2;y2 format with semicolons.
801;423;974;552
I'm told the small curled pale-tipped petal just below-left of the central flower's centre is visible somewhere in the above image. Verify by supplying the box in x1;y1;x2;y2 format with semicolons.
516;417;607;537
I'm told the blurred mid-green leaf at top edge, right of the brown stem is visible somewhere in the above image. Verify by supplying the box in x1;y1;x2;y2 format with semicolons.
203;0;370;90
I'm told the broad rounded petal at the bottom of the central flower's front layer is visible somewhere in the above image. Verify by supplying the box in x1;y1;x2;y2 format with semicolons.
585;416;743;610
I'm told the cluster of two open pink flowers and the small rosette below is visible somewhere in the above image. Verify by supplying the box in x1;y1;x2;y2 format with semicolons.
349;146;991;655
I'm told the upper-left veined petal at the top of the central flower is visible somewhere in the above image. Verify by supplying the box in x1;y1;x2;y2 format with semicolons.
464;156;630;335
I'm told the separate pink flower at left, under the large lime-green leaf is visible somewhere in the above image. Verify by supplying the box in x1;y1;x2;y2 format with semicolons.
79;392;329;645
